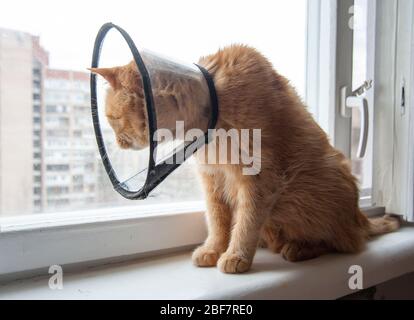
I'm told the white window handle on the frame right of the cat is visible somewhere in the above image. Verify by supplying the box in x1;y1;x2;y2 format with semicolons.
340;80;372;159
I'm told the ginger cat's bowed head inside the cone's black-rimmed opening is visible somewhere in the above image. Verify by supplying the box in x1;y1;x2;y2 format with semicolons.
90;62;148;150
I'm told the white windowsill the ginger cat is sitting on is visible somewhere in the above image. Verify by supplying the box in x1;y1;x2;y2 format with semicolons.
0;227;414;299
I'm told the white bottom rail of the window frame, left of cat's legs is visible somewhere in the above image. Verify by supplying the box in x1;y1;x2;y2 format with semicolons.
0;202;385;282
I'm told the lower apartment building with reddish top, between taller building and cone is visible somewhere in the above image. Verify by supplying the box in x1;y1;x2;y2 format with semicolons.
43;69;99;210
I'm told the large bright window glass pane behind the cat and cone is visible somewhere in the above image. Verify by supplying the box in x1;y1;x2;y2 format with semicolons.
0;0;307;217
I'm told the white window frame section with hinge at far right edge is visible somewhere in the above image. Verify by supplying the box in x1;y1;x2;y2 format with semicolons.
373;0;414;222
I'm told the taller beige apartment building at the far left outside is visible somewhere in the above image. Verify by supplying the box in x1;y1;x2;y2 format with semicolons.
0;29;48;215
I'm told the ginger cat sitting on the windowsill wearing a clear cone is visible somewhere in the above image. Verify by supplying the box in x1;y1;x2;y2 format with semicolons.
92;45;399;273
